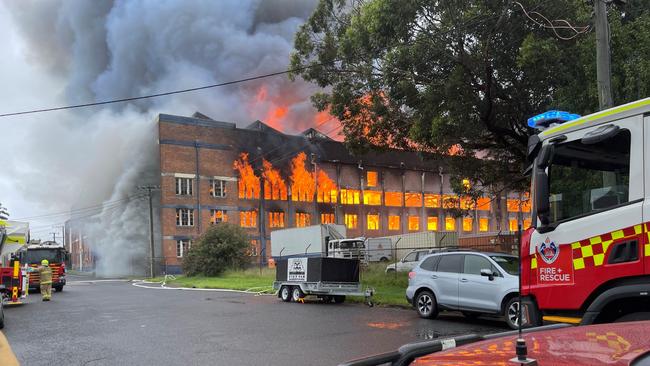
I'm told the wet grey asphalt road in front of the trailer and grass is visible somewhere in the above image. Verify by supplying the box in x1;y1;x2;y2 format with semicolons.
4;278;506;366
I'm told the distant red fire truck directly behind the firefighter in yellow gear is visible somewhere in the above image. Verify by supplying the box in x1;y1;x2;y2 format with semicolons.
15;241;68;291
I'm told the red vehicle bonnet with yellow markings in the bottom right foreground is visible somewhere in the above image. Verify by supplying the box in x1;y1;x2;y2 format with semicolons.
341;321;650;366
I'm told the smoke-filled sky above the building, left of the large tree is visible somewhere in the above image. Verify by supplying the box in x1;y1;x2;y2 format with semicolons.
0;0;335;243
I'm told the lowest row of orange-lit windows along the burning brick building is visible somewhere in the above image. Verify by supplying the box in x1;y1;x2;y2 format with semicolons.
176;208;531;232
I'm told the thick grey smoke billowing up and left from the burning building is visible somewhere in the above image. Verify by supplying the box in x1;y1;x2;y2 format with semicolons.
4;0;322;274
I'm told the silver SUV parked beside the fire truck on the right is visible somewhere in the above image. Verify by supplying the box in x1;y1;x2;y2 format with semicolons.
406;251;519;329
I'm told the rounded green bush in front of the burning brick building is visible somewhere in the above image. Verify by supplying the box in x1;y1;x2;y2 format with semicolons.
183;222;250;276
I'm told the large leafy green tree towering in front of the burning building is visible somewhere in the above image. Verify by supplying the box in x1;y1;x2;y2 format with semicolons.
291;0;650;203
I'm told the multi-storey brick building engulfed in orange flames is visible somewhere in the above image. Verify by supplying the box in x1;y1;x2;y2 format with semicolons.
157;113;530;273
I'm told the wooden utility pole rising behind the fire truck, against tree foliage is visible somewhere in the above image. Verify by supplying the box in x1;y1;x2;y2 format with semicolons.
594;0;614;110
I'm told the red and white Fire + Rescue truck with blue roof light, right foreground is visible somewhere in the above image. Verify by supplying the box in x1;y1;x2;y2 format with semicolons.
521;98;650;325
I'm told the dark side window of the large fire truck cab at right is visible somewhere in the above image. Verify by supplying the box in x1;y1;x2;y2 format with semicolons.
548;130;631;222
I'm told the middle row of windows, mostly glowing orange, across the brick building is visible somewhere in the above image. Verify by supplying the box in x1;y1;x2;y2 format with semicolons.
176;178;530;212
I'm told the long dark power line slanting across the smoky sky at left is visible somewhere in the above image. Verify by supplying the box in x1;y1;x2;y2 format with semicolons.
0;65;318;118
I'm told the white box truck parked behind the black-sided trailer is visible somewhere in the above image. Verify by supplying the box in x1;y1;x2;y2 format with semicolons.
271;224;366;261
